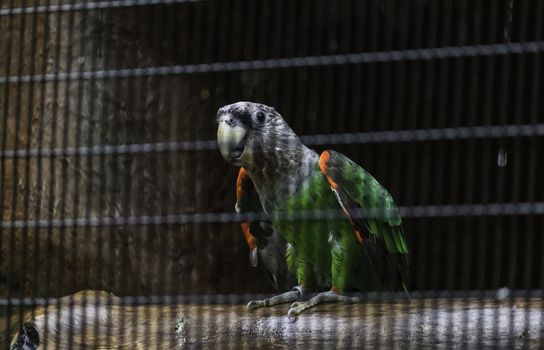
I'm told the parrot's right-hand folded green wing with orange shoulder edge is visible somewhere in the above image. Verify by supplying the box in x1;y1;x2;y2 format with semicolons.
319;151;409;290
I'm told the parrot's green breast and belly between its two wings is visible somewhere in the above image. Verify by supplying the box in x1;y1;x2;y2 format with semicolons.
246;149;356;290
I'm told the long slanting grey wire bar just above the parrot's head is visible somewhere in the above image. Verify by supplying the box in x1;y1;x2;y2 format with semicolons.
0;41;544;84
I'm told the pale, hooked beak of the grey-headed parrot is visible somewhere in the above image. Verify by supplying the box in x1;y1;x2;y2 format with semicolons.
217;121;247;163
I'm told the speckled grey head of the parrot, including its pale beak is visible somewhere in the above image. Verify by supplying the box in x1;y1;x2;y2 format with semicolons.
217;102;300;166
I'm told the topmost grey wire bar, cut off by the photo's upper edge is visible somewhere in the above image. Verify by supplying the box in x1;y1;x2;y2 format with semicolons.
0;0;204;16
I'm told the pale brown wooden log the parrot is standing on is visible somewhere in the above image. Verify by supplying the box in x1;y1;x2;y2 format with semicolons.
3;294;544;349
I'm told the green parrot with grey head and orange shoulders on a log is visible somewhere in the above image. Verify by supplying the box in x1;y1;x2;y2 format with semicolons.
217;102;409;319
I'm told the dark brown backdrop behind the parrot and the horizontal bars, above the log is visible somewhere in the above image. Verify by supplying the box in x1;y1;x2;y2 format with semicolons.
0;0;544;296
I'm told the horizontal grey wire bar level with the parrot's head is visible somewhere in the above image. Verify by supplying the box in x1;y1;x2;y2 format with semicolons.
0;124;544;158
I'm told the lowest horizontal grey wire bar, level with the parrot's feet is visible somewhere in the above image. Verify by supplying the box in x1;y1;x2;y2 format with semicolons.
0;288;544;307
